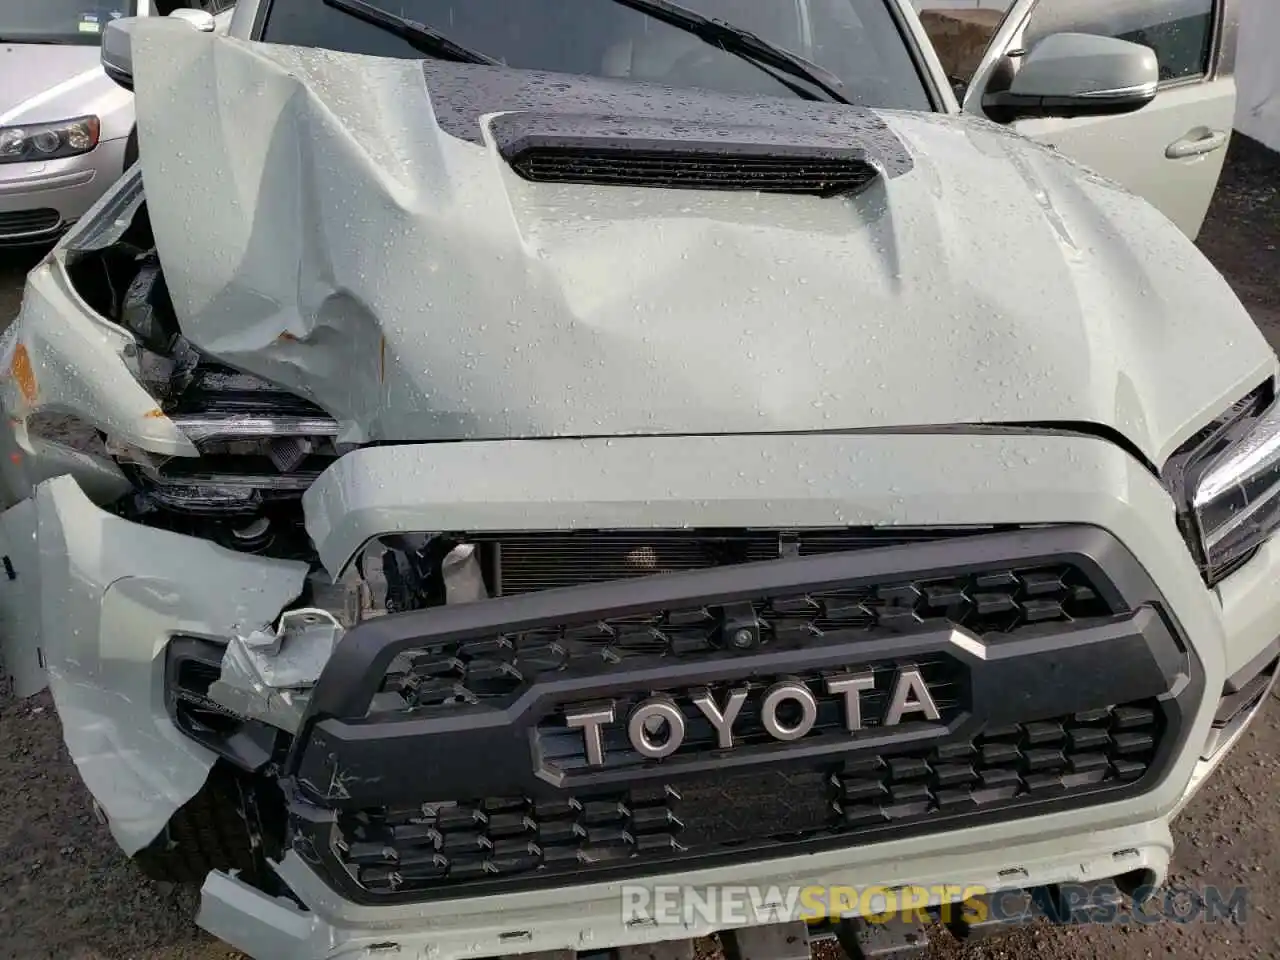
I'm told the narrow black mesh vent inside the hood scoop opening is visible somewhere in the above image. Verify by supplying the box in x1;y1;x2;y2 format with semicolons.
501;147;877;197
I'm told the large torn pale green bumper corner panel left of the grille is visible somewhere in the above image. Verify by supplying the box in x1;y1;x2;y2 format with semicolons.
30;476;307;854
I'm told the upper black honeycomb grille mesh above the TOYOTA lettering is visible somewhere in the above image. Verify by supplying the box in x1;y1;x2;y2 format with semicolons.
379;560;1114;712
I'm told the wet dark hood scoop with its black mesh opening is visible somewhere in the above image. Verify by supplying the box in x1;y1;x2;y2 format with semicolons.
490;114;881;197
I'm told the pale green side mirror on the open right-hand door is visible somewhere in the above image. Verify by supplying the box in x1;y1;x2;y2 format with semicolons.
982;33;1160;123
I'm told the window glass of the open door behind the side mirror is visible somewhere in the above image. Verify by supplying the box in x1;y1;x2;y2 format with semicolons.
1023;0;1213;82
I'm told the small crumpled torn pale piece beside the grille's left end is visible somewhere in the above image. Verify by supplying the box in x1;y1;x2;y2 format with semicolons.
209;608;344;732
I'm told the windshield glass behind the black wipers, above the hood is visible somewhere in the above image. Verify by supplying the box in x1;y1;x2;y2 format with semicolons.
262;0;931;110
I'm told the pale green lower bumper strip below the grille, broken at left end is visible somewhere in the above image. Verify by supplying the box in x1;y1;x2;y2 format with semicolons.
197;822;1172;960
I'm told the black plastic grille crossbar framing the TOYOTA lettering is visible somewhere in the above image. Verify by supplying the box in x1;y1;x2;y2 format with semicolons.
296;608;1185;808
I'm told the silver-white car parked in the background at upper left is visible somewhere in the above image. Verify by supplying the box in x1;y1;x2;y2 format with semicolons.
0;0;228;244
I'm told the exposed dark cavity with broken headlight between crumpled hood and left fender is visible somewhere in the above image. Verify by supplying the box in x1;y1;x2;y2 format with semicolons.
68;206;343;559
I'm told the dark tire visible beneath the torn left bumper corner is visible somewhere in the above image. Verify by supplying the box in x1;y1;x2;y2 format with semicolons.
133;764;262;884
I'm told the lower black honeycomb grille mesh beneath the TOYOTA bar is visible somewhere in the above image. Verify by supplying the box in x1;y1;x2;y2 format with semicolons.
327;701;1166;897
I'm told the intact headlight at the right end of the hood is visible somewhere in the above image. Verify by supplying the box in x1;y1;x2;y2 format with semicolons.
1164;381;1280;586
